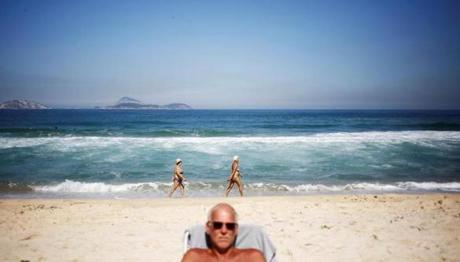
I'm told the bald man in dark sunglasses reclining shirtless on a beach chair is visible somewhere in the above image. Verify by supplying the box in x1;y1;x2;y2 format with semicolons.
182;203;265;262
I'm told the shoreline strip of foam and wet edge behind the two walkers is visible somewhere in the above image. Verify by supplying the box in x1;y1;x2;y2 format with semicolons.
0;180;460;199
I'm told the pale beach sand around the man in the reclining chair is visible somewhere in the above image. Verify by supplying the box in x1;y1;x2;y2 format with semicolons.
0;194;460;261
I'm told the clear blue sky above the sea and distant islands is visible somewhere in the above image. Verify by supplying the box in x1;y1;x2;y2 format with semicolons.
0;0;460;109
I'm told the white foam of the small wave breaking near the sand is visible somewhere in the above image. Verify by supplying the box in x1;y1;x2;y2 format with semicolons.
32;180;460;194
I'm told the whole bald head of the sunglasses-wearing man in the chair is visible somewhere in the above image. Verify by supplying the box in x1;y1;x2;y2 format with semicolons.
206;203;238;252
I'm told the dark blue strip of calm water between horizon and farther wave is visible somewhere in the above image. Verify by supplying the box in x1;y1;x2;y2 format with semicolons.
0;110;460;137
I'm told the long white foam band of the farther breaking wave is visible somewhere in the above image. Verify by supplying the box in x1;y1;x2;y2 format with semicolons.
0;131;460;149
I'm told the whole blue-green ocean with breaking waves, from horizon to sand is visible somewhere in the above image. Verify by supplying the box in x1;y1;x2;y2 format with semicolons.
0;110;460;198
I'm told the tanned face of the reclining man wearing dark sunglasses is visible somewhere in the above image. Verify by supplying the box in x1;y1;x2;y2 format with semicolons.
206;208;238;251
